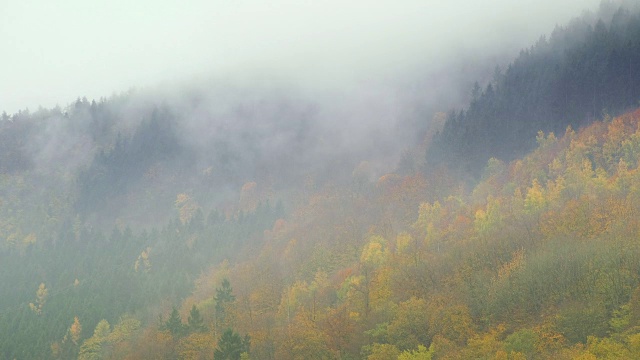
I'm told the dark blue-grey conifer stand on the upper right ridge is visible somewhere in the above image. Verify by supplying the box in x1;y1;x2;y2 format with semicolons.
427;2;640;175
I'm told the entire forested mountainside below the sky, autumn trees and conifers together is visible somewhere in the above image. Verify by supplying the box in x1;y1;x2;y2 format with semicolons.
0;2;640;360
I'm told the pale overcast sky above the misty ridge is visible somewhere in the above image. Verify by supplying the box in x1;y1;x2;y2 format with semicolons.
0;0;600;113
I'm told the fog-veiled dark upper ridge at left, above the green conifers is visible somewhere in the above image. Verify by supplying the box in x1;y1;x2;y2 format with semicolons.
0;89;344;228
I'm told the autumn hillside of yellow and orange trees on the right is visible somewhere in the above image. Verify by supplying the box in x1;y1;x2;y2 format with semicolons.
122;110;640;359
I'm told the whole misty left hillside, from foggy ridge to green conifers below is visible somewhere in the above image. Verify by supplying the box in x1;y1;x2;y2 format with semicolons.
0;78;424;359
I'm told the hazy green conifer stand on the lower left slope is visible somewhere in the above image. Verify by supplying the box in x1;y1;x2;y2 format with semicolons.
0;203;284;359
